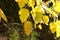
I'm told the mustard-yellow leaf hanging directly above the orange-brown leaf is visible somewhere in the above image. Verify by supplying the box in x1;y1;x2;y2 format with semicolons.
19;8;29;23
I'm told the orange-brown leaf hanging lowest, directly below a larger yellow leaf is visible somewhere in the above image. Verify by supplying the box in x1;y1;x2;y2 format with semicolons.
24;21;32;36
